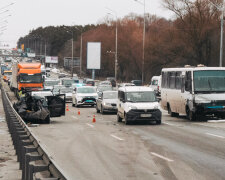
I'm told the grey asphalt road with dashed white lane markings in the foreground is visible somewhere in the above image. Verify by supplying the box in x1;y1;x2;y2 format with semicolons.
27;104;225;180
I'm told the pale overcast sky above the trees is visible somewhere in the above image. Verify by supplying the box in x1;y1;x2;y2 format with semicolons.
0;0;173;47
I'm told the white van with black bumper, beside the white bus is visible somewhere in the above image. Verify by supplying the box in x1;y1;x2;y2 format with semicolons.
117;86;162;124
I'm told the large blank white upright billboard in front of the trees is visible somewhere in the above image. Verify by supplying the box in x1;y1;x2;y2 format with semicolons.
87;42;101;69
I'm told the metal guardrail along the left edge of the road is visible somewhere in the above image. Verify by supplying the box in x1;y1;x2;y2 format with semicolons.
1;88;68;180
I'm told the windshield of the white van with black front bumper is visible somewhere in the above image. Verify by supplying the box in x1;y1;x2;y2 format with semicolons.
125;91;157;102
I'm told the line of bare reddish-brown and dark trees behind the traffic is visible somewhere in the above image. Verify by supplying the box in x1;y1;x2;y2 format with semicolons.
18;0;222;82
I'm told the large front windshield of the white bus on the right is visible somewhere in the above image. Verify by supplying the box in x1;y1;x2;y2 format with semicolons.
194;70;225;93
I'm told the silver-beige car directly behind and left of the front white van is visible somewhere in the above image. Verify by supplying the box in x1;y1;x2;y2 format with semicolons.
96;91;118;114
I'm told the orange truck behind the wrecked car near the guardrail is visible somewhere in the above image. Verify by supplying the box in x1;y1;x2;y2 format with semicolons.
10;63;43;96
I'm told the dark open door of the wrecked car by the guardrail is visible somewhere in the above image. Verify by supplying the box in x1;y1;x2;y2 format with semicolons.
46;94;66;117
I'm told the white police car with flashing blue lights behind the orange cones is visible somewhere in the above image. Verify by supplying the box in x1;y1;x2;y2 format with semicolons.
72;86;98;107
